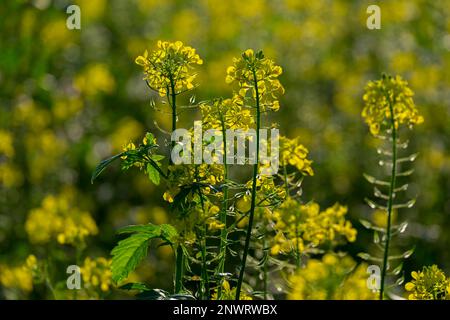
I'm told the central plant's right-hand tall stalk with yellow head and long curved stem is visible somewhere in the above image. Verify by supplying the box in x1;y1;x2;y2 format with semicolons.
226;49;284;300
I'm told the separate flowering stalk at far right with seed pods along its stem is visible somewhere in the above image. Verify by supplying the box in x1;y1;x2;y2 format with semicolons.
362;75;423;300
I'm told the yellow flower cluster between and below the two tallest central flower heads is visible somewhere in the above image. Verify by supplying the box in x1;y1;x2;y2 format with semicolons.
200;96;254;131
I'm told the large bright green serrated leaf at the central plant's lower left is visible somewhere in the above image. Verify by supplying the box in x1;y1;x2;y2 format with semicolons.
111;233;154;283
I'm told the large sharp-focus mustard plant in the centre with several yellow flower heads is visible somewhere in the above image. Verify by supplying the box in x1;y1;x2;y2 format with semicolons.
92;42;356;300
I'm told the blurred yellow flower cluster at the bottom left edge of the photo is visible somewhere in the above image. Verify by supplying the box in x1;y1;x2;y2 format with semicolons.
0;255;37;293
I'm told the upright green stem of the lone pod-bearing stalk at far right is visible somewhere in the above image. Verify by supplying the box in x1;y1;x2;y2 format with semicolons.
379;99;397;300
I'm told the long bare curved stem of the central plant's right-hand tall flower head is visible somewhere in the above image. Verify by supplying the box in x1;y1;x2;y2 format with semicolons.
236;70;261;300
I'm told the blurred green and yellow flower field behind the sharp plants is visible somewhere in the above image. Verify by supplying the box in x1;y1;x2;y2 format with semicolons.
0;0;450;298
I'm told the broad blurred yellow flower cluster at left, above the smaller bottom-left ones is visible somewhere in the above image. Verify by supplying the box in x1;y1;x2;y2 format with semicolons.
25;190;98;245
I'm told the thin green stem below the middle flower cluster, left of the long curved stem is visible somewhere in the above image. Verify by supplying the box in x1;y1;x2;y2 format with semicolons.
217;114;228;300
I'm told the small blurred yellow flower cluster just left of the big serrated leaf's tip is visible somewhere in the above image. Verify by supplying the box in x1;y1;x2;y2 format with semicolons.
81;257;112;292
